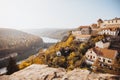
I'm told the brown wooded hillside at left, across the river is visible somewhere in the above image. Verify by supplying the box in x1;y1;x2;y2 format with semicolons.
0;28;43;67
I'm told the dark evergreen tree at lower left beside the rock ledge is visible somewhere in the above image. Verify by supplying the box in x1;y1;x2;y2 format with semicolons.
7;57;19;75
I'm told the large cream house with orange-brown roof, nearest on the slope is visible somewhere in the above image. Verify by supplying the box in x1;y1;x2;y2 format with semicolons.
85;48;118;66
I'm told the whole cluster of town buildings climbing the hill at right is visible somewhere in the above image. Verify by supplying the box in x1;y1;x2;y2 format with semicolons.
72;17;120;74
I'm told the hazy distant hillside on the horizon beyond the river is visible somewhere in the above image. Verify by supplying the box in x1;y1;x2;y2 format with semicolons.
22;28;71;40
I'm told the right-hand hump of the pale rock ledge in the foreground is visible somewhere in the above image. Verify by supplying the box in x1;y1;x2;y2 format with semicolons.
62;69;120;80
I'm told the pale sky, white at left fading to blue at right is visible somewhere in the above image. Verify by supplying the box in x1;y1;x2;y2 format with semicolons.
0;0;120;29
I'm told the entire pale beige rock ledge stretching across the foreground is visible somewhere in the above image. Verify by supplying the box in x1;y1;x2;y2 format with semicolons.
0;64;120;80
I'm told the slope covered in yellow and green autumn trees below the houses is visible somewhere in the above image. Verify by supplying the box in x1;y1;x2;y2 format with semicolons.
18;35;119;74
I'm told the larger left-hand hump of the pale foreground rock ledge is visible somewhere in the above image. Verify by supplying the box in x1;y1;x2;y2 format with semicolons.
9;64;66;80
